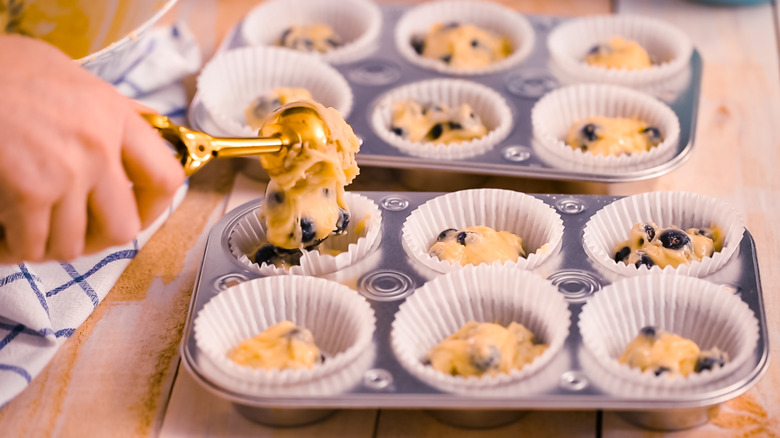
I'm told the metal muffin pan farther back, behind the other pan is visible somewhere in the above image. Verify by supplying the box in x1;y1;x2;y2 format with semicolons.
188;6;702;182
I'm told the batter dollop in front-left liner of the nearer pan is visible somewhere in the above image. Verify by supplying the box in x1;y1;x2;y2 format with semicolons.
228;321;322;370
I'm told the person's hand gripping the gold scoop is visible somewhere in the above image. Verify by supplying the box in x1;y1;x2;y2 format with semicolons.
0;35;184;263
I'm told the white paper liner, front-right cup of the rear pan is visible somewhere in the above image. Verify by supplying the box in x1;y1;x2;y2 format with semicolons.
531;84;680;174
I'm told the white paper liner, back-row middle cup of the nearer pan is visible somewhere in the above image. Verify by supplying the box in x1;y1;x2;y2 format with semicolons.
401;189;563;272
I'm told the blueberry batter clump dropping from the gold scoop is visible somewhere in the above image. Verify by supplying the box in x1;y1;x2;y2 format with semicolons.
259;101;360;250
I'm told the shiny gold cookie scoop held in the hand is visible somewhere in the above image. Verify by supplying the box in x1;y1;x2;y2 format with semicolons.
141;102;330;176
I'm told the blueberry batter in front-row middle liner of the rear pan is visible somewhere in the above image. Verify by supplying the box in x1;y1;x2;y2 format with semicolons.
390;99;488;143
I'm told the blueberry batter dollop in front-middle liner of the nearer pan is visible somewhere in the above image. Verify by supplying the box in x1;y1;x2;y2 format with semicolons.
426;321;547;376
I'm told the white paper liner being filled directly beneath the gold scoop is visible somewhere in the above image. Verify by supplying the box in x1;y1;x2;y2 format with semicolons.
228;192;382;275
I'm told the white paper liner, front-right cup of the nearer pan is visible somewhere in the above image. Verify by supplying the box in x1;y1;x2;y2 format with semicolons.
578;273;758;398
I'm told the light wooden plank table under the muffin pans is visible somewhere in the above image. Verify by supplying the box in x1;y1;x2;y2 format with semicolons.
0;0;780;438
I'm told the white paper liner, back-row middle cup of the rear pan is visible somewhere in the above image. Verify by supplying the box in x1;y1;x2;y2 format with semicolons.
395;1;535;75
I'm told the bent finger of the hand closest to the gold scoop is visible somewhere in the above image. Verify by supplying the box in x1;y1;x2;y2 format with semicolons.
122;114;184;228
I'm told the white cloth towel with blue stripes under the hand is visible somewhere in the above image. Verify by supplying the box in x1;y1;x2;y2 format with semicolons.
0;23;202;409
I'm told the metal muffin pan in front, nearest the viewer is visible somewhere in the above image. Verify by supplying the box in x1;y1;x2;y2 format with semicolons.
182;192;769;430
